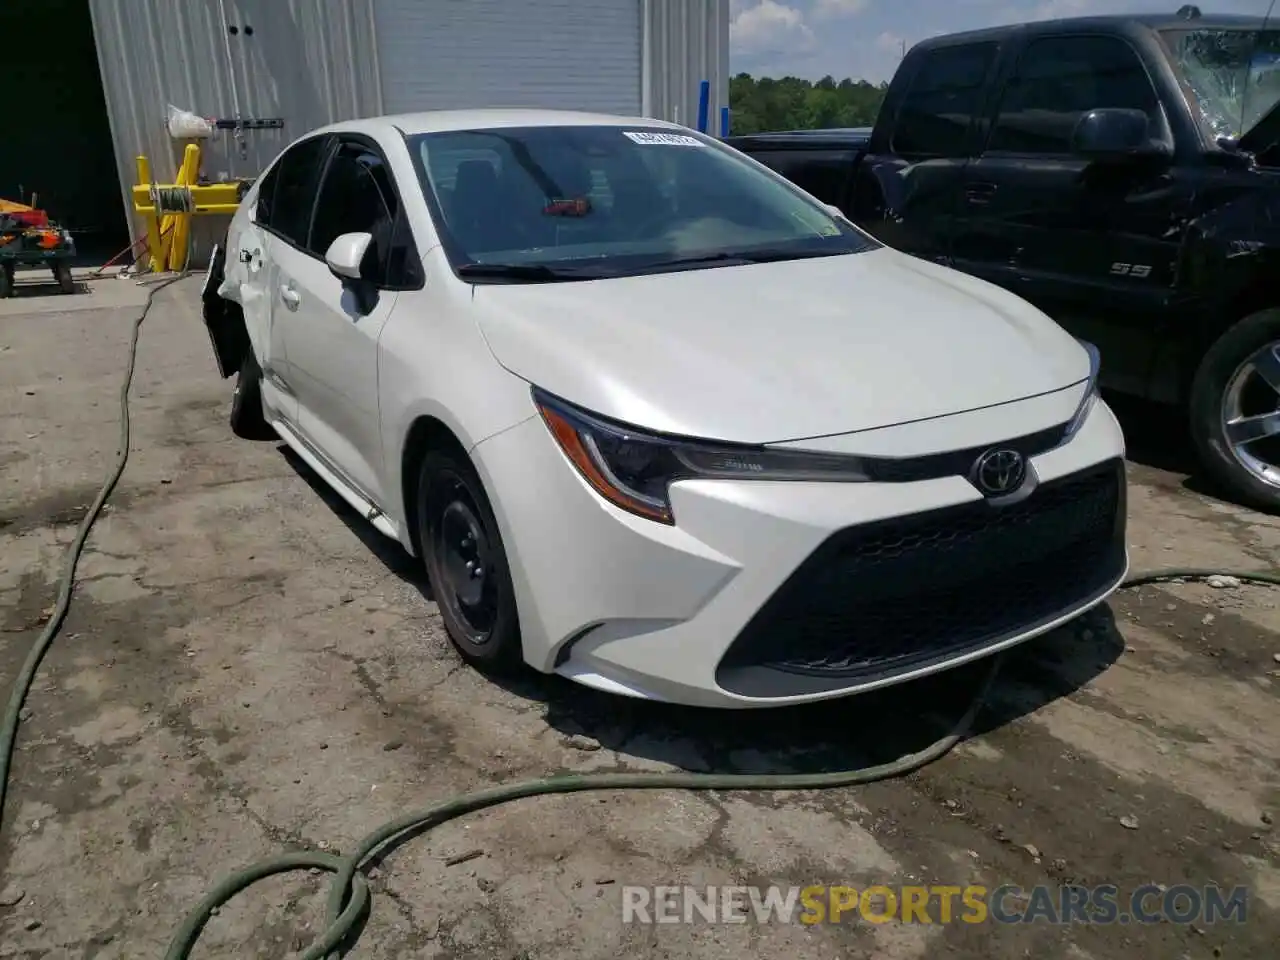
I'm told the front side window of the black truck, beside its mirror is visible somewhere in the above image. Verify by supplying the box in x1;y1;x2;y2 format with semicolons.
987;36;1161;154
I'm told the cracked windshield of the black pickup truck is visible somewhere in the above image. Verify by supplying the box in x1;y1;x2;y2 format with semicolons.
1165;29;1280;140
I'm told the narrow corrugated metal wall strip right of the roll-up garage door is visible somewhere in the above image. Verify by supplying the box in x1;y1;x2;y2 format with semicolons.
640;0;730;136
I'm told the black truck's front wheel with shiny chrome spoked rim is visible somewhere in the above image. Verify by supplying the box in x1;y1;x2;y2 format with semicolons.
1190;307;1280;513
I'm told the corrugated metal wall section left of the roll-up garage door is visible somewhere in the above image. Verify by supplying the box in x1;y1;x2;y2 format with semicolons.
90;0;381;260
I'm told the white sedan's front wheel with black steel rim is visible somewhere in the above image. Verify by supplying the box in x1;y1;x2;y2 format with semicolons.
417;449;524;673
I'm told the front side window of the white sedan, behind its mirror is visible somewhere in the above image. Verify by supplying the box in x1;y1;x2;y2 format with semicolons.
307;142;397;282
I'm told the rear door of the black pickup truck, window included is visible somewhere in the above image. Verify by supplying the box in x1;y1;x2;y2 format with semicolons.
852;41;1000;264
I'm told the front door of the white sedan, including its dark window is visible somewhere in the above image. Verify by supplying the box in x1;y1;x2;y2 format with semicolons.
276;134;399;504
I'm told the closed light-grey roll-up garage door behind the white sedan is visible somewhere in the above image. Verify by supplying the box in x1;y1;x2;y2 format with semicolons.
374;0;641;115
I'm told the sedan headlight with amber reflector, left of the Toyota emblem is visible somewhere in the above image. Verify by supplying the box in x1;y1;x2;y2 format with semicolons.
534;388;869;524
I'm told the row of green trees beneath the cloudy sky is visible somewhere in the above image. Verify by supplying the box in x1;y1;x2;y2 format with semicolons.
728;73;888;136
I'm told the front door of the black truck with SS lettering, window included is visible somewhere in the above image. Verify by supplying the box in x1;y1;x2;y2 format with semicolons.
952;35;1193;393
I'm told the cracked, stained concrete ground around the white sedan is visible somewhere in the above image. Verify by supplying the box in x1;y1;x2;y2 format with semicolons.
0;273;1280;960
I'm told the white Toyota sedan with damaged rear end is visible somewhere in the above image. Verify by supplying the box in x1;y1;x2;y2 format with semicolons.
204;110;1128;707
